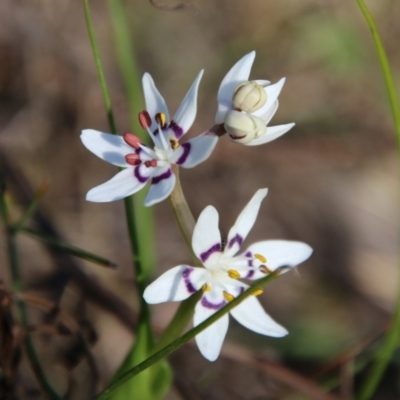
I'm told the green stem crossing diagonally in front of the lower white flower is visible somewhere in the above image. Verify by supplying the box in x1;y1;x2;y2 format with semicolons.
93;269;280;400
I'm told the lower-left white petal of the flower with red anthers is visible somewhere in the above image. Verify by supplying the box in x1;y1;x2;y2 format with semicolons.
86;167;147;203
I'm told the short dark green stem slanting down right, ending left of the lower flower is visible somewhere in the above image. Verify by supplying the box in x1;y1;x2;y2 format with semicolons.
22;227;117;268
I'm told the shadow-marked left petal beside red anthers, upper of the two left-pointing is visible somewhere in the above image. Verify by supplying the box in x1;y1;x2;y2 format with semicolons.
81;129;135;167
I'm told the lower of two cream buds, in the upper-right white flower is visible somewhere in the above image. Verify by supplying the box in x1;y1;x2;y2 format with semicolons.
224;111;267;144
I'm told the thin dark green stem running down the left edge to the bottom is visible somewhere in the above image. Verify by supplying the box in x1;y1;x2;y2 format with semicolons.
0;175;62;400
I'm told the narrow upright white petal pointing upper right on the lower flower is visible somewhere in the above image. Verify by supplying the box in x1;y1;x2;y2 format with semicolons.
224;189;268;256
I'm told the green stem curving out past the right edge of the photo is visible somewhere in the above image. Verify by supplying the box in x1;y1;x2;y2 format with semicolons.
357;0;400;400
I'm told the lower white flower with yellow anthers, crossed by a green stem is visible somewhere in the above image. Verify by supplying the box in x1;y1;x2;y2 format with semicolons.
144;189;312;361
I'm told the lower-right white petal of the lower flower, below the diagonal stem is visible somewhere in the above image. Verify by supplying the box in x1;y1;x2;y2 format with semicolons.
230;296;288;337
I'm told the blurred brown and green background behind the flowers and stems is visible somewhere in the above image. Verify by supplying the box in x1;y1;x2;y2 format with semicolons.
0;0;400;400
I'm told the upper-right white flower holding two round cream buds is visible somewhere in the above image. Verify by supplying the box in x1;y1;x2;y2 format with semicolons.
215;51;294;146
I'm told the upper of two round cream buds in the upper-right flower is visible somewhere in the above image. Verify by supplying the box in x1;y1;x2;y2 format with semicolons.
232;81;267;113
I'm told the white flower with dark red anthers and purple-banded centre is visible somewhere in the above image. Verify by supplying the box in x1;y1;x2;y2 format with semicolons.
81;71;218;206
